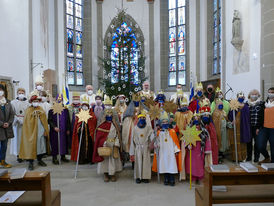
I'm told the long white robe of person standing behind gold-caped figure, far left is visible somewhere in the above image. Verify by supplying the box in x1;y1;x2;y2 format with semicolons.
10;99;29;156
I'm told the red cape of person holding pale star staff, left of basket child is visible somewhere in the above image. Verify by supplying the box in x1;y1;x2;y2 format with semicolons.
71;109;97;161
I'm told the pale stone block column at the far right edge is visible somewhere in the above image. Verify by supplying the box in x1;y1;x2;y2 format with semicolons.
261;0;274;98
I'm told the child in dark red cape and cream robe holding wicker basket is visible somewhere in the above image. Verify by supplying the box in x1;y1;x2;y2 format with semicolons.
93;109;122;182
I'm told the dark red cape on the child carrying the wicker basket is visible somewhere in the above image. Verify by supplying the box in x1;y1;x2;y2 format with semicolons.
92;121;111;163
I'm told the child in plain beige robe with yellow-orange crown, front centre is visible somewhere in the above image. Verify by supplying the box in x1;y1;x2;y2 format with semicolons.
129;111;154;184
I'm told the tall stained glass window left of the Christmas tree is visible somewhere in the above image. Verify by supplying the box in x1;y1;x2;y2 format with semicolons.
65;0;84;85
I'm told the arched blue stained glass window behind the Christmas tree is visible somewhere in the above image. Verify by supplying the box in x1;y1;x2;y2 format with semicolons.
111;22;140;85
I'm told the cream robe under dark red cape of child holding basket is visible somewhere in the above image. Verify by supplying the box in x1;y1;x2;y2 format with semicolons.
97;124;122;175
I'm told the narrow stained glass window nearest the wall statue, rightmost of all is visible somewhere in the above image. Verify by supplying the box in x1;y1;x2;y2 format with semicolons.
212;0;222;75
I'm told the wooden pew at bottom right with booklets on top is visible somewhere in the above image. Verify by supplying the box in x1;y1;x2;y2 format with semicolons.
195;167;274;206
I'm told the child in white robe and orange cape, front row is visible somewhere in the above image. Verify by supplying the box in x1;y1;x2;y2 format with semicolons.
152;111;182;186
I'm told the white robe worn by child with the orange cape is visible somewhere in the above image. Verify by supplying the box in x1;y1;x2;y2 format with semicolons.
159;130;180;174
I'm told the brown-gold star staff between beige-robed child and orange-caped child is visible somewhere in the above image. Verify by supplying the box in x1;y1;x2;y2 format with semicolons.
148;104;161;183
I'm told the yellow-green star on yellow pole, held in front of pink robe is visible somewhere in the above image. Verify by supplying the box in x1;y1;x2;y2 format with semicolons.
181;125;201;189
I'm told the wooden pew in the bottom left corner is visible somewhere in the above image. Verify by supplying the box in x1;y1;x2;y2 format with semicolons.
0;172;61;206
